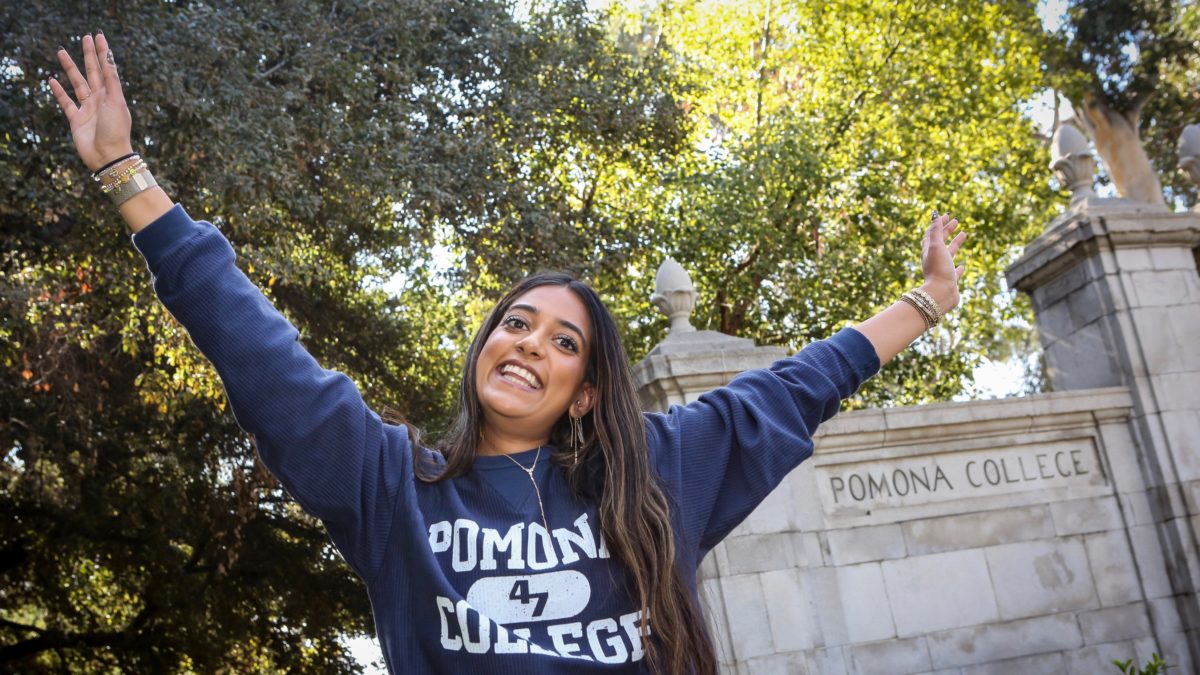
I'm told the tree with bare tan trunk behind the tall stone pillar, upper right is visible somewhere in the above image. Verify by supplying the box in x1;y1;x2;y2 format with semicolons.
1045;0;1200;204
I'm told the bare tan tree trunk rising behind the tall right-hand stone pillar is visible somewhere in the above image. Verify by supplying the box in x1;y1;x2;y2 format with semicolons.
1074;94;1165;204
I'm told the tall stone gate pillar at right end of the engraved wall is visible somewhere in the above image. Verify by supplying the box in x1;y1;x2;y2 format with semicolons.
1007;198;1200;663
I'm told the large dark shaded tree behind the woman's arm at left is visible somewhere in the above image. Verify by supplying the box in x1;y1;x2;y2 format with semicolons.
0;0;682;673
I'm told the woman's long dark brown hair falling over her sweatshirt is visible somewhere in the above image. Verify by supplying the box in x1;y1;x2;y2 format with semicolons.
409;274;716;675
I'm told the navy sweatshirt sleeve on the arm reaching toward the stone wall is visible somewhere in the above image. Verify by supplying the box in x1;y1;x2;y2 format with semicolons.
646;328;880;555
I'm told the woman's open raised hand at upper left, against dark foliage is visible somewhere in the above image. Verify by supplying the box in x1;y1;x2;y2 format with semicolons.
50;32;133;172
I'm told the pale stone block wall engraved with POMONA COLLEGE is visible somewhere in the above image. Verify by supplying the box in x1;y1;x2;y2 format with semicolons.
701;388;1187;675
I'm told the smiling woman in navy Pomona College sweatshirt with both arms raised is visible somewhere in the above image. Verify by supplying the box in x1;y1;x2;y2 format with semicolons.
50;30;964;674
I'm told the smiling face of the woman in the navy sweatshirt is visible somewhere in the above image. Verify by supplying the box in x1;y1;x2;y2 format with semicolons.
475;286;593;442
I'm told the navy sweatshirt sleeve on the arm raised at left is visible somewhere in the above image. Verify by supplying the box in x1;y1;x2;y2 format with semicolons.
133;204;413;579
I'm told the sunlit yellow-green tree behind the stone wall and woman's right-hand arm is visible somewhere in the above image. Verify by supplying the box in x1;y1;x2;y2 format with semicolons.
585;0;1055;405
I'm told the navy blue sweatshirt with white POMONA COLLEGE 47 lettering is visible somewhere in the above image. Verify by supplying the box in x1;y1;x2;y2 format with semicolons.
133;205;880;673
